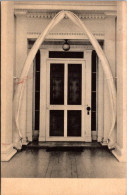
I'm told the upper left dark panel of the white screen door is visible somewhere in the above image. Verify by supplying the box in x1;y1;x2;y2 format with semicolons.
50;64;64;105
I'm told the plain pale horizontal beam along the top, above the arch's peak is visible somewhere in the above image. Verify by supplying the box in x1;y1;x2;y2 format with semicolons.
14;1;117;11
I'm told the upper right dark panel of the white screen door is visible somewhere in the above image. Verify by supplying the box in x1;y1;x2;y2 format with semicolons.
68;64;82;105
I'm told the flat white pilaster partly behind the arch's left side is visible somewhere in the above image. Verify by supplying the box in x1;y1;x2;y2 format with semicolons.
16;12;28;145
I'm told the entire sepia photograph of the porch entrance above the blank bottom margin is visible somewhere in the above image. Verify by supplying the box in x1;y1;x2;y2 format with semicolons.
1;1;127;195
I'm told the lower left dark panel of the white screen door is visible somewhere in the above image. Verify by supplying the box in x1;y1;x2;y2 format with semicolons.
50;110;64;136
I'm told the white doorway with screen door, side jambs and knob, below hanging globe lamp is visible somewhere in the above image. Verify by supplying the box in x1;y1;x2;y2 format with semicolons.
39;49;95;142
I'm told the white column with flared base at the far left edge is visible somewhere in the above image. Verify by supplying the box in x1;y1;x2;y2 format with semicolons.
1;2;16;161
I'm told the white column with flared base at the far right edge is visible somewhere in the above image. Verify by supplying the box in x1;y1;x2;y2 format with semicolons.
112;2;127;162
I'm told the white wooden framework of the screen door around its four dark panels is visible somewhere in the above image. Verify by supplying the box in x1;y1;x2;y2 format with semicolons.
46;59;85;141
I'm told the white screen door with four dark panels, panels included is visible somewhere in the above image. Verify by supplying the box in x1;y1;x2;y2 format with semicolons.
46;60;91;141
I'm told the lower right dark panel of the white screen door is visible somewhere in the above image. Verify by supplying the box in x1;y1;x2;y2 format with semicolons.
67;110;81;136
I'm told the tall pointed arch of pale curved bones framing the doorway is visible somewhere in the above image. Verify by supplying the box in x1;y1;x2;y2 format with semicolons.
14;11;116;148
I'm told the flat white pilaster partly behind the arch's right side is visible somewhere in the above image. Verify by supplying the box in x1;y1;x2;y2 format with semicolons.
103;16;116;145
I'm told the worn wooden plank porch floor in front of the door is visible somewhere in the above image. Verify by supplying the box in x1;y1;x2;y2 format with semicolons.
1;147;126;178
